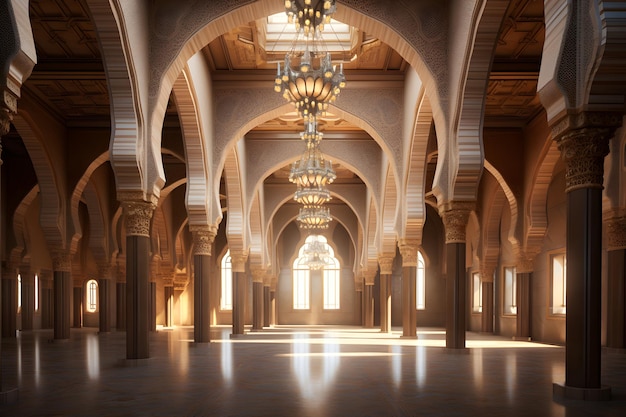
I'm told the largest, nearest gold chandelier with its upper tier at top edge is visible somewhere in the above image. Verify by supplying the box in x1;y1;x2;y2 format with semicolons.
274;0;346;121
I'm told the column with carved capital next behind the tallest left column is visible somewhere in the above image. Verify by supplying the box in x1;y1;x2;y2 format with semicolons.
190;226;217;343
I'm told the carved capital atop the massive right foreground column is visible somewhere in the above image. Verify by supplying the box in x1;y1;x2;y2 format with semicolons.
556;127;615;192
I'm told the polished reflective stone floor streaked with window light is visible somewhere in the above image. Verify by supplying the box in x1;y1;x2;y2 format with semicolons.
0;326;626;417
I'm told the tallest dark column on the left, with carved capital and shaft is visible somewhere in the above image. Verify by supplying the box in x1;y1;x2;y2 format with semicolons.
122;201;156;359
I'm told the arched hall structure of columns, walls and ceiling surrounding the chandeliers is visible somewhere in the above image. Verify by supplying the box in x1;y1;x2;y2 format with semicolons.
0;0;626;410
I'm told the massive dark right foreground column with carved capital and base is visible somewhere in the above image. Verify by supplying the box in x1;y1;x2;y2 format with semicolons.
552;113;622;400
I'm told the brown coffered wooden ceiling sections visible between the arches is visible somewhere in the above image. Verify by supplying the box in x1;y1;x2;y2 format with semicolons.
24;0;544;136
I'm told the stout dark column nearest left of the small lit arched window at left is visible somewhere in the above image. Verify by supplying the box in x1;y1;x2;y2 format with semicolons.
52;250;72;340
